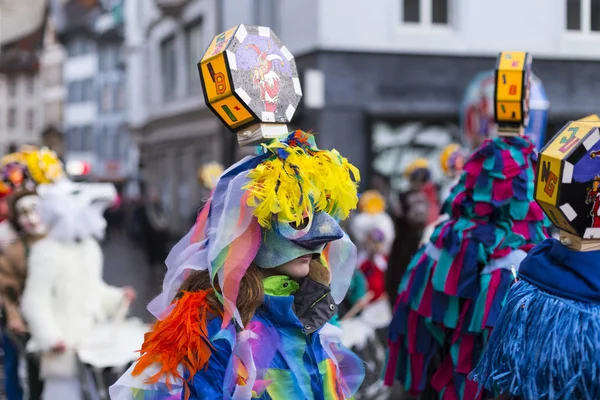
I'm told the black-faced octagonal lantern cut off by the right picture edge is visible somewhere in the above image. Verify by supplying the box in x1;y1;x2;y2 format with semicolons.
535;115;600;240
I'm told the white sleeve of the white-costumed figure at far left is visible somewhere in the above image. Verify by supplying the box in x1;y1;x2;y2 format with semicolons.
21;242;63;350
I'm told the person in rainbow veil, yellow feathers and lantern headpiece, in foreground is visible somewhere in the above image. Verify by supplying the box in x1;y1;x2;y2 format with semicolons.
110;25;364;400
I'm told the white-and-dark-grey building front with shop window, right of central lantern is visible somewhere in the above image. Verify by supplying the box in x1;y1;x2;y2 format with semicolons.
266;0;600;189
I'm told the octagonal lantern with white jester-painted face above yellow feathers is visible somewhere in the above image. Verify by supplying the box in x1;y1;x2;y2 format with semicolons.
198;25;302;144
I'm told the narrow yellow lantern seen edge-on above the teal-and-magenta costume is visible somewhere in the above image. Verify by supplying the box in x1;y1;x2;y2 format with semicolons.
494;51;531;135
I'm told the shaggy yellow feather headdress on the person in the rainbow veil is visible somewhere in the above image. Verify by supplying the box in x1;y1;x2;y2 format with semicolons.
244;130;360;228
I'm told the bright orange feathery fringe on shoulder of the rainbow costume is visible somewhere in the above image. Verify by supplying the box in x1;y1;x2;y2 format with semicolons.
132;289;220;399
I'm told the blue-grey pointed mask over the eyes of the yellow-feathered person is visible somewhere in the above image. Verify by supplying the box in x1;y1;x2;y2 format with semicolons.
254;212;344;268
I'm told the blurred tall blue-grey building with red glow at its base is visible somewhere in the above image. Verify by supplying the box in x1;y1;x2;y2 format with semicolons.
58;0;138;182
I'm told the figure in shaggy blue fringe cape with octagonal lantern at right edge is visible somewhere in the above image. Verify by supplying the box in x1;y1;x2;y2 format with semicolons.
471;116;600;400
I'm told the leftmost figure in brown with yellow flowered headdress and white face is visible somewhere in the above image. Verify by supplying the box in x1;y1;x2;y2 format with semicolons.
0;146;62;400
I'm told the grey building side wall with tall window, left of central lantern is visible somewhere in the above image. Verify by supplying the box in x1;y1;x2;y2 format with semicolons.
125;0;223;232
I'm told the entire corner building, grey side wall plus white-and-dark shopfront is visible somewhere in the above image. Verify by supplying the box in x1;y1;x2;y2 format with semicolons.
126;0;600;229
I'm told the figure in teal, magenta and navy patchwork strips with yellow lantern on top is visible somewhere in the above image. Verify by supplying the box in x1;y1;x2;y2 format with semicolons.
385;52;548;400
